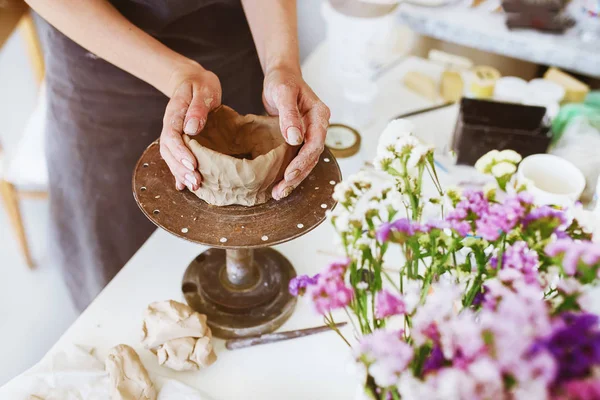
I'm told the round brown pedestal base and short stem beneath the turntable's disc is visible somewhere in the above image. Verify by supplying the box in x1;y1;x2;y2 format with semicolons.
182;248;296;339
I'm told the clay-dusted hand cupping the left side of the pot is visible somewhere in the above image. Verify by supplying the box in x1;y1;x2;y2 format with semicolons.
160;63;221;190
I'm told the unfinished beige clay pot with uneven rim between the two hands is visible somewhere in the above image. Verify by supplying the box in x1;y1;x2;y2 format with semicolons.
183;106;298;206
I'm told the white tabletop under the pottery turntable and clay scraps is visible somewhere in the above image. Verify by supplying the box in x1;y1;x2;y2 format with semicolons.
0;45;455;400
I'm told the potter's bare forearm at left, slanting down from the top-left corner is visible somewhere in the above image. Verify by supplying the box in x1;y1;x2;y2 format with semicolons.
26;0;199;96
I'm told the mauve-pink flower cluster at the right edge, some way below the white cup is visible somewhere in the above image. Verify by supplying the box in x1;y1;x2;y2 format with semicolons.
545;239;600;276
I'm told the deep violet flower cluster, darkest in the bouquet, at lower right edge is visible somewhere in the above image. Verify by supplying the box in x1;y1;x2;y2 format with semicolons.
537;313;600;383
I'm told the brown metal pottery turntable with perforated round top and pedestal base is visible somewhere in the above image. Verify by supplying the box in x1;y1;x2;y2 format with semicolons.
133;141;341;338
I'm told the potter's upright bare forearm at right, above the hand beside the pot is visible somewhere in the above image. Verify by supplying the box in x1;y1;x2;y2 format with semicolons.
242;0;300;72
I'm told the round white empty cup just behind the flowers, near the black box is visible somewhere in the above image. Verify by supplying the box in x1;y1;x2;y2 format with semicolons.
517;154;585;207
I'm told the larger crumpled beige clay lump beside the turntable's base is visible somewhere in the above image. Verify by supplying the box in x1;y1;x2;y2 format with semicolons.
142;300;217;371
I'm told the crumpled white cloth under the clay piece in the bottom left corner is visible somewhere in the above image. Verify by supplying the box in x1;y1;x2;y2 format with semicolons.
0;345;213;400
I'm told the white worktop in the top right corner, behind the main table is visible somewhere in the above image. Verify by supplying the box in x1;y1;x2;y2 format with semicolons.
399;0;600;78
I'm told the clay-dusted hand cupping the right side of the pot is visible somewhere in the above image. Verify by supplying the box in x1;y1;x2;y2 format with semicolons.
263;67;330;200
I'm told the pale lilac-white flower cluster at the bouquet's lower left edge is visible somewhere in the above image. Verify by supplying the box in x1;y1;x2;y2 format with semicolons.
354;329;413;387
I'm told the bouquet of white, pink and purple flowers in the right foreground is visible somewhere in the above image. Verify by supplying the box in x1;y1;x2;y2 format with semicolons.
290;120;600;400
